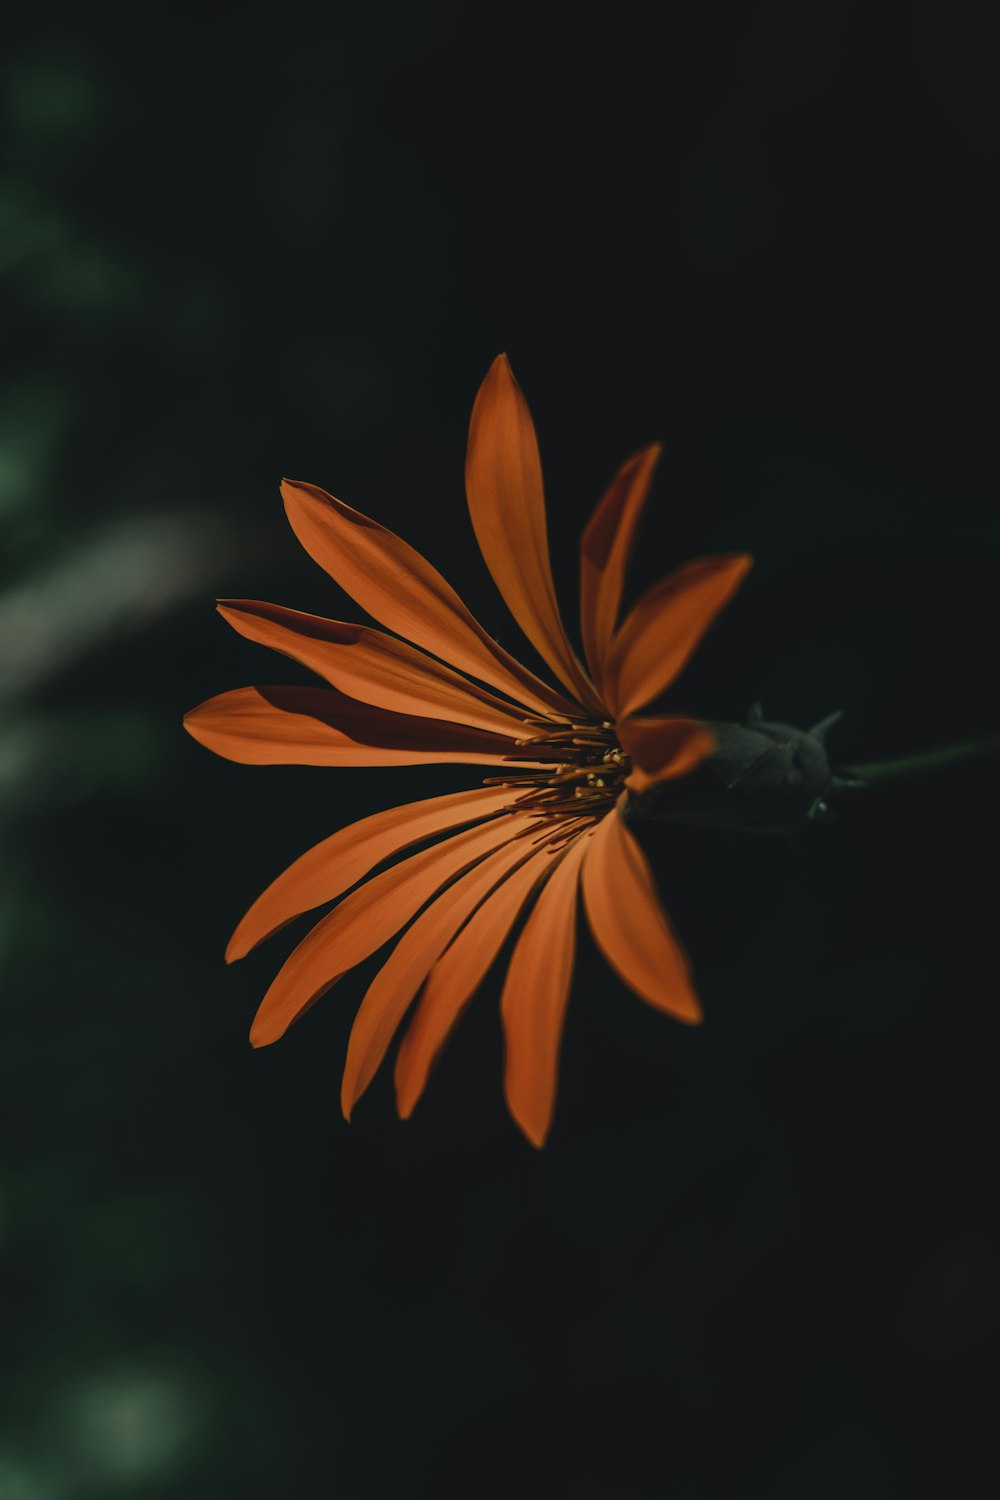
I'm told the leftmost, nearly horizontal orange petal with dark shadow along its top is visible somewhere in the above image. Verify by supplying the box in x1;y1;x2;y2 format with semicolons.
184;687;551;765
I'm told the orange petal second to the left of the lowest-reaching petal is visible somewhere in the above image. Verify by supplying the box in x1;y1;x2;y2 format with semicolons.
340;816;531;1119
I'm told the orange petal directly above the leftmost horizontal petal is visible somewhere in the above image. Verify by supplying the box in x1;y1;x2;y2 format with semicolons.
217;599;536;738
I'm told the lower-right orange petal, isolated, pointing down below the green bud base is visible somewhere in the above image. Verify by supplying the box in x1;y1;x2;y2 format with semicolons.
583;812;702;1023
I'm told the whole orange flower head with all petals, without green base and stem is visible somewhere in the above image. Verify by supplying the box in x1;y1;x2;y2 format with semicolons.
184;356;751;1146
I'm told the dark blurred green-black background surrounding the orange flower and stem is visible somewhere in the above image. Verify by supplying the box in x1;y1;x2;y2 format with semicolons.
0;0;1000;1500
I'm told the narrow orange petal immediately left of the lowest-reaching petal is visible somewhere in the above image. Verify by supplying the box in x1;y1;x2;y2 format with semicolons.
396;848;553;1119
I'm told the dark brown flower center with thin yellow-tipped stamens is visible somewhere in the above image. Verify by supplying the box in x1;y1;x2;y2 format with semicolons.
484;719;631;833
